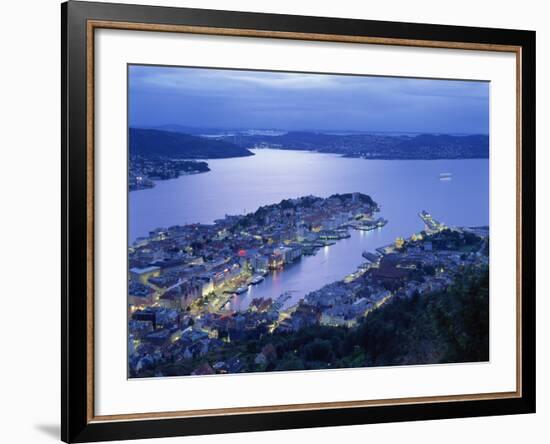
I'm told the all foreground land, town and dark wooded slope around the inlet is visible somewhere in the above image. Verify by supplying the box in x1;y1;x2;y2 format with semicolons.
129;193;489;377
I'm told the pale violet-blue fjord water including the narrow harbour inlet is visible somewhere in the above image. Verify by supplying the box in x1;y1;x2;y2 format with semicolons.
129;150;489;306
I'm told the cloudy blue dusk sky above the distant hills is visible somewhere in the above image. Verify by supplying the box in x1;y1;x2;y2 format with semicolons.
129;66;489;134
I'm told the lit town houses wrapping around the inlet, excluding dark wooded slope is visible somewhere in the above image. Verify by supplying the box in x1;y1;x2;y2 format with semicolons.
128;193;488;377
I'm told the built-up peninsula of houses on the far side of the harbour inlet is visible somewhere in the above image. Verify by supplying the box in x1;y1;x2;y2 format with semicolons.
128;193;376;310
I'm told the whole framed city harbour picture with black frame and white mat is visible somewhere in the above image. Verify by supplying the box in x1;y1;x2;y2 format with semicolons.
61;1;535;442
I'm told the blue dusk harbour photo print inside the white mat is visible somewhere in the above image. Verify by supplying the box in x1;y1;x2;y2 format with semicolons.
127;65;492;378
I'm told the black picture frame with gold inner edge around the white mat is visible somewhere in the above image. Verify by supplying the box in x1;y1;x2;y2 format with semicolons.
61;1;536;442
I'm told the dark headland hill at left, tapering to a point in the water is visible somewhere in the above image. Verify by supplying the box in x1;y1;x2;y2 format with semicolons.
129;128;254;159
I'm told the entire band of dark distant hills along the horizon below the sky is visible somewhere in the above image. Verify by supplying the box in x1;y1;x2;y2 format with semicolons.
130;125;489;160
